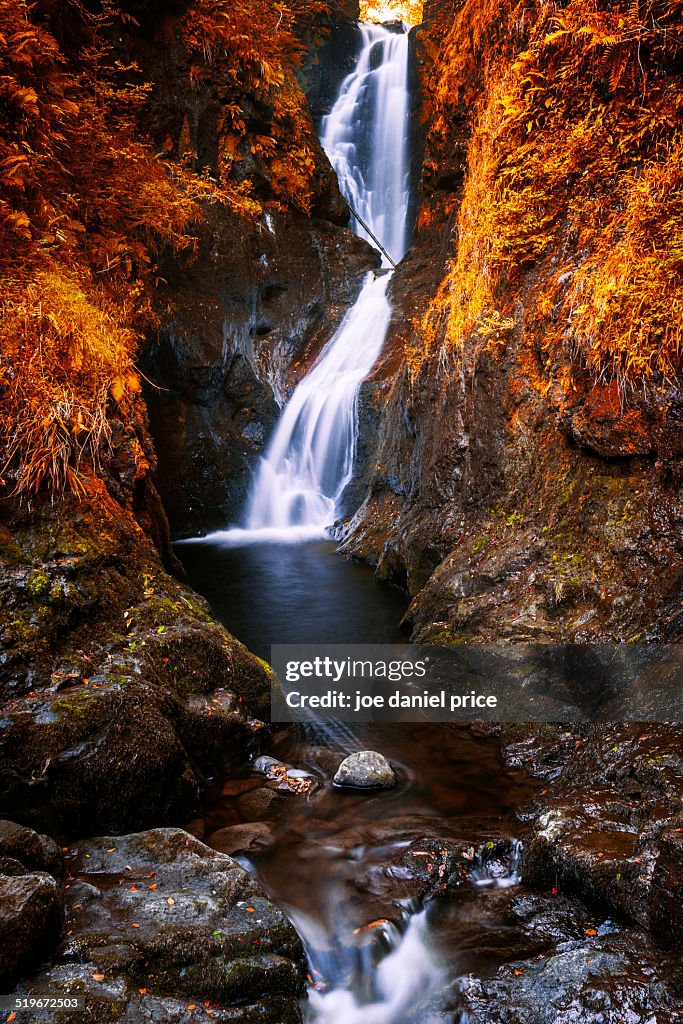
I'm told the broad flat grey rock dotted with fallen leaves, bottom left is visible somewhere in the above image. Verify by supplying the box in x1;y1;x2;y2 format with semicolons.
6;828;306;1024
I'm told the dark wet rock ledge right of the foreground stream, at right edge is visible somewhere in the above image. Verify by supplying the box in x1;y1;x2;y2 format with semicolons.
503;723;683;945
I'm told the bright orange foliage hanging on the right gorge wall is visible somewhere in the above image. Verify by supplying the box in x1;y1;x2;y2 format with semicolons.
414;0;683;382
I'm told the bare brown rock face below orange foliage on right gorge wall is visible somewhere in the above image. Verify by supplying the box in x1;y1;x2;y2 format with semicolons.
340;5;683;643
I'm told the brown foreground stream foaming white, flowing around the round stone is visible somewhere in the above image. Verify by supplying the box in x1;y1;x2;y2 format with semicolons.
198;723;536;1024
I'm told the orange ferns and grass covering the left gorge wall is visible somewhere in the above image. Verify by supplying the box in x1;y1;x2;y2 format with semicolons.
0;0;328;493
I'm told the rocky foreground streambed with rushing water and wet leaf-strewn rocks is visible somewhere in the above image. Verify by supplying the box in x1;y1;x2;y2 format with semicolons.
0;725;683;1024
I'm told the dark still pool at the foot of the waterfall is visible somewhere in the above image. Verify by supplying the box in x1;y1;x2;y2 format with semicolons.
175;538;407;659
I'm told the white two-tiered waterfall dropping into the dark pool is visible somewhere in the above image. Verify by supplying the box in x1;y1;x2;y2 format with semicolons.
212;25;410;544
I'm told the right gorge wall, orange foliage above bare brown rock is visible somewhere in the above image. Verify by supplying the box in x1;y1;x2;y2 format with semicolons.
341;2;683;642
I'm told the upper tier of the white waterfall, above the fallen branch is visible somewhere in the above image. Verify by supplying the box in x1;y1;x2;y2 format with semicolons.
321;25;410;263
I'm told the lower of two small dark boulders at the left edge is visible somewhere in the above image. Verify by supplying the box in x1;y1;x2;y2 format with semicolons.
0;861;63;986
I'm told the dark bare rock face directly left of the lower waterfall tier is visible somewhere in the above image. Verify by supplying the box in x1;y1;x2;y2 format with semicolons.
143;204;378;536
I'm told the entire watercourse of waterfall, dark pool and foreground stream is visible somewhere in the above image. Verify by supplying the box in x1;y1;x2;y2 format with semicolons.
178;18;679;1024
